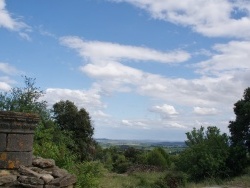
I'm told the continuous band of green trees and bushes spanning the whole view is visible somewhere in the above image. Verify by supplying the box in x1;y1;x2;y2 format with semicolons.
0;77;250;188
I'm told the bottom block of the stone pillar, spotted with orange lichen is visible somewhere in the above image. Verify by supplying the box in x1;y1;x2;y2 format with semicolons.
0;152;32;169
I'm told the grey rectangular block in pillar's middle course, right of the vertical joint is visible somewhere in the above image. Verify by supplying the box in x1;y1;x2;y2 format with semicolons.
6;134;34;151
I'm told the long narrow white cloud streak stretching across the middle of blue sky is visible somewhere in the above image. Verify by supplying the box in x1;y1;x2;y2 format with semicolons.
60;36;190;64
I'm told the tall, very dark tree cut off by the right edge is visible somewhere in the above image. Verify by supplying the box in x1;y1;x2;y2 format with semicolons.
228;88;250;175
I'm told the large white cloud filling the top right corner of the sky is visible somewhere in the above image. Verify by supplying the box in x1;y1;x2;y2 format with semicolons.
109;0;250;38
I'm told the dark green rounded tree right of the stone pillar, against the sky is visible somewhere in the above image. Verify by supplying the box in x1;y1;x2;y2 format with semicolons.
52;100;96;160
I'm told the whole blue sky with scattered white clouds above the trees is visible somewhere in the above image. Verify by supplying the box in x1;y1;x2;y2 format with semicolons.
0;0;250;141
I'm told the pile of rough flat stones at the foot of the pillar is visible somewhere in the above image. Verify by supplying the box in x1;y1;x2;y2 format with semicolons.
0;157;77;188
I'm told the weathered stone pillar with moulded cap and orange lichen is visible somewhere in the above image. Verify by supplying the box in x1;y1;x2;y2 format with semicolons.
0;111;39;169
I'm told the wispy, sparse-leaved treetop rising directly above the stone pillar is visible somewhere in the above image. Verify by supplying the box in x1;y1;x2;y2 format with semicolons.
0;76;47;117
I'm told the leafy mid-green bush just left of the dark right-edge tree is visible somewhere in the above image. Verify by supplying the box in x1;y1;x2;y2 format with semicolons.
177;127;229;181
